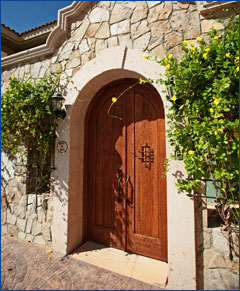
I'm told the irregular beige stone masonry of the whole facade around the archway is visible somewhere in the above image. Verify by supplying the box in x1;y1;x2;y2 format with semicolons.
1;1;238;289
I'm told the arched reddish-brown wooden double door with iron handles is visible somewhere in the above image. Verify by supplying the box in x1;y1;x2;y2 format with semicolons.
85;80;167;261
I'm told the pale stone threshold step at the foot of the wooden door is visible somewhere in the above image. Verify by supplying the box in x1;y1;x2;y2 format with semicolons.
71;241;168;288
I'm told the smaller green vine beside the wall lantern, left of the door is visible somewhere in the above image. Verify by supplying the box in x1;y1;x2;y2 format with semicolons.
1;75;59;187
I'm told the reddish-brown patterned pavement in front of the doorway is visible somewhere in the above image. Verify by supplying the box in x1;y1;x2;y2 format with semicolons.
1;236;162;290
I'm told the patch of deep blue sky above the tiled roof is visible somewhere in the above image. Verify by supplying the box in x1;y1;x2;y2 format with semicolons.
1;0;73;33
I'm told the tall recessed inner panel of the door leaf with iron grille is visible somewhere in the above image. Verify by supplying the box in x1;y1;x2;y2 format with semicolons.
134;94;159;237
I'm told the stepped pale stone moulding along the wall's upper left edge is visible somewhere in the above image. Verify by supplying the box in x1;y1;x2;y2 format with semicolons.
1;1;91;68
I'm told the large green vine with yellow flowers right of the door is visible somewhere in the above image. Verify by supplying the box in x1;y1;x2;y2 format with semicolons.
154;16;239;213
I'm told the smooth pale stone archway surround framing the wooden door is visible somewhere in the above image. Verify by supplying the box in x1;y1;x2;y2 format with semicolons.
53;47;196;289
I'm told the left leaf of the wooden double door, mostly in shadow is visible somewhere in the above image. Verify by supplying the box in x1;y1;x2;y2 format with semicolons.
88;86;126;249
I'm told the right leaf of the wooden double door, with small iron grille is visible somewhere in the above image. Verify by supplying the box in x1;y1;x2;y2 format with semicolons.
127;85;167;261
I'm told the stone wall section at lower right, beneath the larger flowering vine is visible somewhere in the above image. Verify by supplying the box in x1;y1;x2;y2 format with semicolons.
195;198;239;290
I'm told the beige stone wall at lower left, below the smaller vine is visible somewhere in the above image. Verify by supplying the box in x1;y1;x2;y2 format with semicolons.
1;153;53;246
